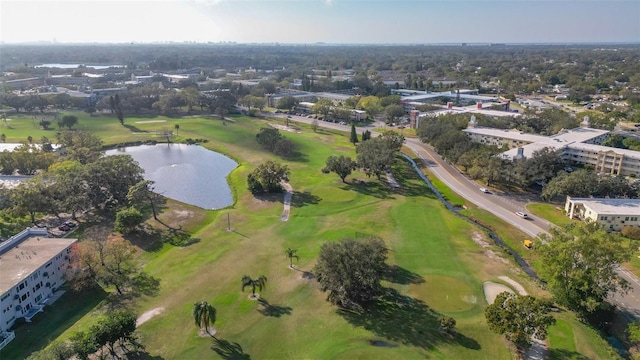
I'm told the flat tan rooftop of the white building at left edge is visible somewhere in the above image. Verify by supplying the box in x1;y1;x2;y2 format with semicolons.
0;236;77;294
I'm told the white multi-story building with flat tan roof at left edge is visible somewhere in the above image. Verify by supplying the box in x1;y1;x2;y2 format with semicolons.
0;228;76;349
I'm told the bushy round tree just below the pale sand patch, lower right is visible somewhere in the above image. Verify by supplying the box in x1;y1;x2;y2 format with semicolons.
484;291;556;353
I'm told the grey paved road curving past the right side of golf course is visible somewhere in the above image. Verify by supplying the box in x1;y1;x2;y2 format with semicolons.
278;114;640;320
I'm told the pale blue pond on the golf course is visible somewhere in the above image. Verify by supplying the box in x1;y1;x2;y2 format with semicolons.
107;144;238;209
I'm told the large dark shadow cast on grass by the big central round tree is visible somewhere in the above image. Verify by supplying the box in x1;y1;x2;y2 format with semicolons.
338;288;444;349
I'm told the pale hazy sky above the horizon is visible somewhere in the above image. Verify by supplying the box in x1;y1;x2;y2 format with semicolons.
0;0;640;44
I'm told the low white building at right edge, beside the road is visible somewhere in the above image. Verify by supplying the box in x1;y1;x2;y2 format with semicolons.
564;196;640;231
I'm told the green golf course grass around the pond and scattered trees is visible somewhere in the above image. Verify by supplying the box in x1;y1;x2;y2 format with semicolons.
0;114;616;359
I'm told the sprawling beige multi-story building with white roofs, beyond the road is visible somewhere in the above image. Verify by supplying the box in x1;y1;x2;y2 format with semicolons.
463;116;640;176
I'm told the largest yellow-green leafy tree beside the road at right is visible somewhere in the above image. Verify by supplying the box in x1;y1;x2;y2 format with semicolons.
537;223;630;315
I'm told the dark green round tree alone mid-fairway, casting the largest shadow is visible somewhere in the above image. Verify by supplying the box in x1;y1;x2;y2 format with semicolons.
314;238;388;308
